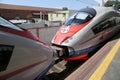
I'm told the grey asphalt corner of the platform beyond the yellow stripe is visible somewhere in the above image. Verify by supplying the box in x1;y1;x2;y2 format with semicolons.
102;47;120;80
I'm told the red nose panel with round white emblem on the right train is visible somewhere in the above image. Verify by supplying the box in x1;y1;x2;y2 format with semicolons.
52;22;89;45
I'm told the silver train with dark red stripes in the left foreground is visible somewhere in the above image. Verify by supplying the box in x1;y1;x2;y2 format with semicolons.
0;17;55;80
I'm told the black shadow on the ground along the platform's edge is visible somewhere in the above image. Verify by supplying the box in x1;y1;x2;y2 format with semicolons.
42;60;85;80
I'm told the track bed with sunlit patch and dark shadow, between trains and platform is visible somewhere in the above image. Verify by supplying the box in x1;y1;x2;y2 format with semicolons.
42;60;85;80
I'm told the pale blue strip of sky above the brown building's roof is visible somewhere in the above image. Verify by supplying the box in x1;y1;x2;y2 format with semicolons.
0;0;99;10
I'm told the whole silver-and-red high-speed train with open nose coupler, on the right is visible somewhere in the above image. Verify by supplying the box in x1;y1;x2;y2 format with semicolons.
51;7;120;60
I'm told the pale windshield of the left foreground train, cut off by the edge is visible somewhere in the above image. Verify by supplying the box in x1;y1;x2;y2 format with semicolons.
0;17;23;31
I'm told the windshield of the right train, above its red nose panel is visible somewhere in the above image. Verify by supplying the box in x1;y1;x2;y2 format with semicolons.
65;11;93;26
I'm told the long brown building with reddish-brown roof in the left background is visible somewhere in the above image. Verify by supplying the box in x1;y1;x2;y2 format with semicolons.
0;4;61;20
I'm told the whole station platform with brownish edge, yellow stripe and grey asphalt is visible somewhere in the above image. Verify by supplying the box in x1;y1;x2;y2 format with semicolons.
65;37;120;80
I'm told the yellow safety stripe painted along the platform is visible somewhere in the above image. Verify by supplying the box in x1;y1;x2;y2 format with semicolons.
89;40;120;80
